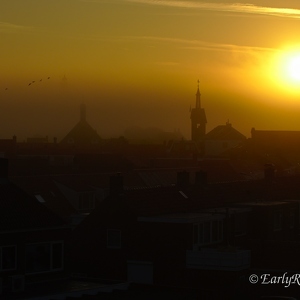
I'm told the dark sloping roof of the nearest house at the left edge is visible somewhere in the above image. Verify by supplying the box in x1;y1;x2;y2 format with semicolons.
0;180;65;232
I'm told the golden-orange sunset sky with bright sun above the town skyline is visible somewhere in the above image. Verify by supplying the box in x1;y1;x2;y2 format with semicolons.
0;0;300;140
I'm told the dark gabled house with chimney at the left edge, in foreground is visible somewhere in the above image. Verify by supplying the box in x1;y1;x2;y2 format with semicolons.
0;159;70;299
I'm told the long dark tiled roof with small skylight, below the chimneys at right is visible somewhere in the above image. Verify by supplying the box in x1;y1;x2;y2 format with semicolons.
70;176;300;244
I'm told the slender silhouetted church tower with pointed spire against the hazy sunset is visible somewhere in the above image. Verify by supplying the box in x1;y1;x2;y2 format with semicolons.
190;80;207;148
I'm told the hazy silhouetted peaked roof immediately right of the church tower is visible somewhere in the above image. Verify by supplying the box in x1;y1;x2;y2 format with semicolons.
205;123;246;140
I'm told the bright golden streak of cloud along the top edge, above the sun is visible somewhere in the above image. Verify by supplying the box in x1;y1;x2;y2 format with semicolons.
124;0;300;18
